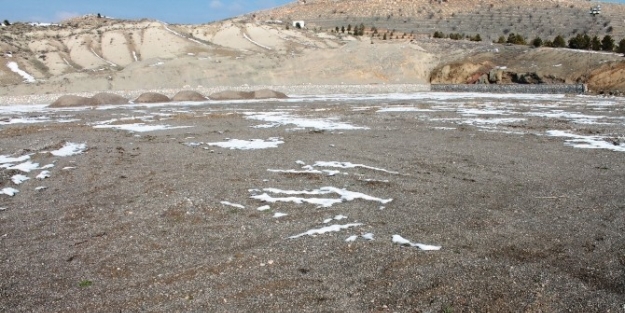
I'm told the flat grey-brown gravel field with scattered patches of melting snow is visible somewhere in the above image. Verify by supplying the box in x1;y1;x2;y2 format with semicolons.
0;93;625;312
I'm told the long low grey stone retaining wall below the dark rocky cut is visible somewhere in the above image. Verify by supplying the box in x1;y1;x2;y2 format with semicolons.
431;84;588;94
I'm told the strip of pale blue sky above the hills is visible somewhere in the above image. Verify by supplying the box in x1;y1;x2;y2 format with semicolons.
0;0;625;24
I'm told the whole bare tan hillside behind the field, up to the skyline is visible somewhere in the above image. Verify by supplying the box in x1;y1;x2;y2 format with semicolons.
0;0;625;100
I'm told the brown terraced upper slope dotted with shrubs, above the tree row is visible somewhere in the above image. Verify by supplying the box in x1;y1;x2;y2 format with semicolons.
256;0;625;41
